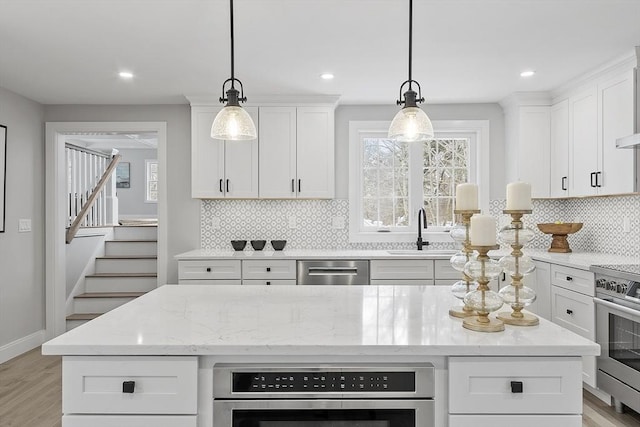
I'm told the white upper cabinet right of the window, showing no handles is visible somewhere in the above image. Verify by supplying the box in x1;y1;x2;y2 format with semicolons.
501;94;551;197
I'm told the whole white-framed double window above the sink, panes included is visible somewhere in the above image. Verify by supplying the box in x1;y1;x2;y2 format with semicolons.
349;121;489;242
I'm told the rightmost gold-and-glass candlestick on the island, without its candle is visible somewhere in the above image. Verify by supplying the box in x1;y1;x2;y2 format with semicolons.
498;210;540;326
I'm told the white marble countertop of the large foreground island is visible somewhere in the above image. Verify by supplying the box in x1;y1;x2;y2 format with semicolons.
42;285;600;356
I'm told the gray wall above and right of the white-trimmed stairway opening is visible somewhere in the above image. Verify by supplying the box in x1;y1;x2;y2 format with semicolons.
44;104;200;283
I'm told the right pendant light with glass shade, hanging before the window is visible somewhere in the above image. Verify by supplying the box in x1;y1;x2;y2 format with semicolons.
389;0;433;142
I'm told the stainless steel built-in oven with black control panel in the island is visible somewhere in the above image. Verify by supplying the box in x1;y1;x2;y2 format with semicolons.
213;364;435;427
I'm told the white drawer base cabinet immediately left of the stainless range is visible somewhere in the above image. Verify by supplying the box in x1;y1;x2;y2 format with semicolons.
551;264;596;388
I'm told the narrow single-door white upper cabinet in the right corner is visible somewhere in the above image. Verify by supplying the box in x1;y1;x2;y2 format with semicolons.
549;99;569;197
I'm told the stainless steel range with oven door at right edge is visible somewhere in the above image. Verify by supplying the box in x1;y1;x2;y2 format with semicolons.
591;265;640;412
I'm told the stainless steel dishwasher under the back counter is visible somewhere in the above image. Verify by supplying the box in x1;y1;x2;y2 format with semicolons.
298;260;369;285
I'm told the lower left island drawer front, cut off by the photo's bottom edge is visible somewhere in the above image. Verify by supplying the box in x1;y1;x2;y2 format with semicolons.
62;415;198;427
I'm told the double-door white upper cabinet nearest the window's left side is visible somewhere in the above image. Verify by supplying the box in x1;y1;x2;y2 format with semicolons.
259;107;335;199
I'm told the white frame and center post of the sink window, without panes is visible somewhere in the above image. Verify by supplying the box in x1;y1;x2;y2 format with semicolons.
349;120;490;243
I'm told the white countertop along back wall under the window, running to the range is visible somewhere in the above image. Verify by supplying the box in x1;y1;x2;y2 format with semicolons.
175;248;640;270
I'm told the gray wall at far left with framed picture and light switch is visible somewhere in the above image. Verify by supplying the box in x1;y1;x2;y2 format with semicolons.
0;88;45;349
